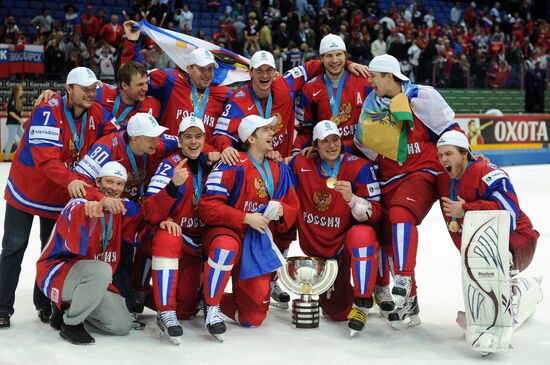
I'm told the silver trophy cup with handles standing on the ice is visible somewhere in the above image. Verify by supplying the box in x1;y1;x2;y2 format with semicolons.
279;256;338;328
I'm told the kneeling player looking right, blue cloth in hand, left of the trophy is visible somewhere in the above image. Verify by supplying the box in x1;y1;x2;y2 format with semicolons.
199;115;299;337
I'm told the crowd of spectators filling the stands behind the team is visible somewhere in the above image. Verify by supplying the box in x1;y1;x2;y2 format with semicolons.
0;0;550;90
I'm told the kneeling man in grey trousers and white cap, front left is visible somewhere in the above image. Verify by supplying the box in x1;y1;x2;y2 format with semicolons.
36;162;149;345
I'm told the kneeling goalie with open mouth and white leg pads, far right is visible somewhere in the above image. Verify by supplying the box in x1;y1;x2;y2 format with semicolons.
437;131;541;355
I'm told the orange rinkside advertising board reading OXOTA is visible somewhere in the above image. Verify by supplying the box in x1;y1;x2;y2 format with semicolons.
455;114;550;150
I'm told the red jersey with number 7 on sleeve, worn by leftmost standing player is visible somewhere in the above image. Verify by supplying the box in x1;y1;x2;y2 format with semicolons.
4;95;117;219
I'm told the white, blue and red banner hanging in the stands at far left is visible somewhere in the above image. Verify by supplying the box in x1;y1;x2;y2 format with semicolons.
0;44;44;79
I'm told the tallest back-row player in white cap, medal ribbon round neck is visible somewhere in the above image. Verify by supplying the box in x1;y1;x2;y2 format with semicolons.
293;34;371;152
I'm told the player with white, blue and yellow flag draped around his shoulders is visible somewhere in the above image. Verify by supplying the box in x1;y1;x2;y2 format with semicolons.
354;55;458;329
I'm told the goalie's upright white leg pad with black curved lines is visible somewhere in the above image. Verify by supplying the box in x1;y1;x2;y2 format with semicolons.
460;211;513;355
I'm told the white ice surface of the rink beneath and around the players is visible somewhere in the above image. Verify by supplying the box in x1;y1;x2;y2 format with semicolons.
0;163;550;365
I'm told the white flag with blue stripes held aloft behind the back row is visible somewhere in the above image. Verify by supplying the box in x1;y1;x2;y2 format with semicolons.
138;20;250;85
